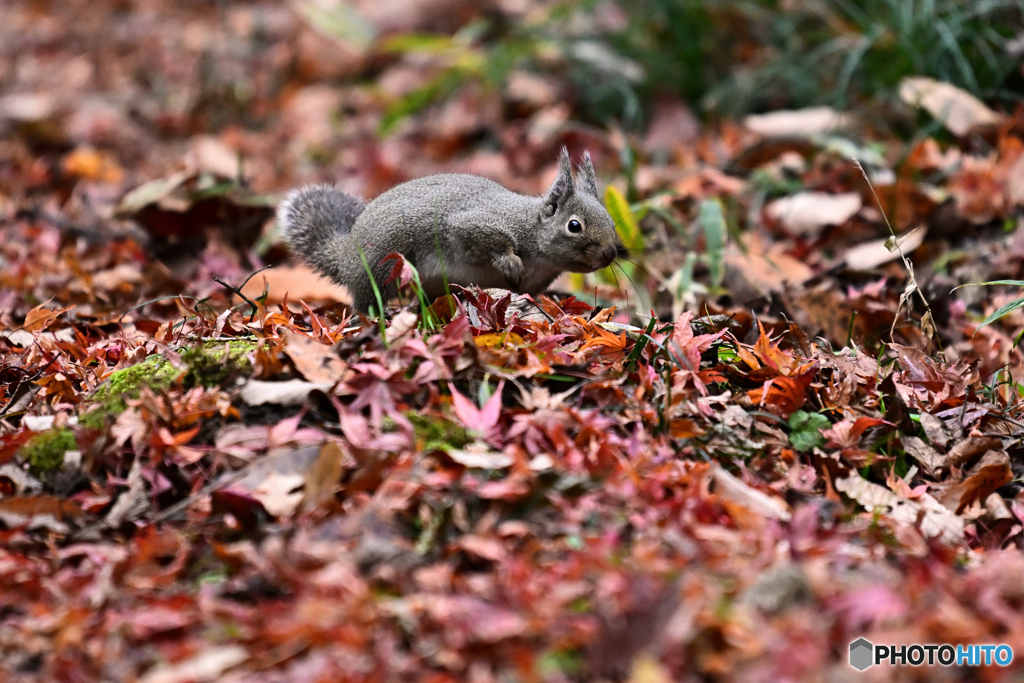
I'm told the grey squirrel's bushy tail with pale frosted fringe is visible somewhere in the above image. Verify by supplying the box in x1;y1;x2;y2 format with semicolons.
278;185;366;272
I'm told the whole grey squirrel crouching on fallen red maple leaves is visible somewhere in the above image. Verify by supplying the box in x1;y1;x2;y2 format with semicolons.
278;147;626;312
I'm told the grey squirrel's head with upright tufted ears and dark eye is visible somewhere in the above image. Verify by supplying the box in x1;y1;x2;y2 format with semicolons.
540;147;625;272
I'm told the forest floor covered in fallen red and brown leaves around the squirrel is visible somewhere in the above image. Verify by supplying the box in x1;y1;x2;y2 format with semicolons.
0;1;1024;683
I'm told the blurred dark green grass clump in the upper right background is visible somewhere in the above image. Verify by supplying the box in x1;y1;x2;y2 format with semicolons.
610;0;1024;115
